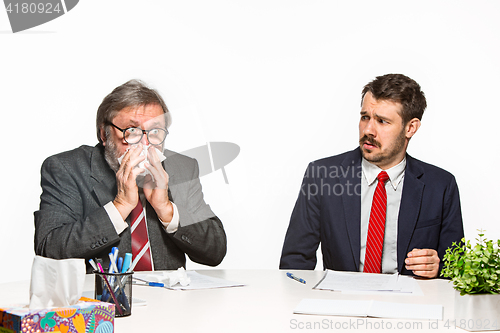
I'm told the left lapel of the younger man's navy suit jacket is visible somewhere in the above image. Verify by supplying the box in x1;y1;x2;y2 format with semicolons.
339;148;361;271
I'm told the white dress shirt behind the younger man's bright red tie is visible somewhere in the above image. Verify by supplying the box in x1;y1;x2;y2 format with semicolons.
359;157;406;273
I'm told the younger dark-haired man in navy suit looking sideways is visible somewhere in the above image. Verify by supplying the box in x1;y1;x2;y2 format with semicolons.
280;74;463;278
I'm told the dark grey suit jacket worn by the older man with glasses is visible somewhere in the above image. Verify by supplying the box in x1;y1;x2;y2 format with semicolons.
35;144;226;271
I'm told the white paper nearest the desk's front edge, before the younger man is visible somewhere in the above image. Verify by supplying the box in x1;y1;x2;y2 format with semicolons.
293;299;443;320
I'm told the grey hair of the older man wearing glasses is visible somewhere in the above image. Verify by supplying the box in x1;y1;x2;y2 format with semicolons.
96;80;172;143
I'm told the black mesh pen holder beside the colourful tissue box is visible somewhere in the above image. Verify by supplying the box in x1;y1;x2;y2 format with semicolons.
94;271;134;317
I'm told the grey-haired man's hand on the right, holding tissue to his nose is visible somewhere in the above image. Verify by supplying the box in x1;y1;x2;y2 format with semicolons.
143;146;174;222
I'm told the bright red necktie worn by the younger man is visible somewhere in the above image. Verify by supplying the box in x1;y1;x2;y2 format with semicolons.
363;171;389;273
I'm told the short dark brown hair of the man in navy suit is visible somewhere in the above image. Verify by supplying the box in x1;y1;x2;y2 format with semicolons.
361;74;427;124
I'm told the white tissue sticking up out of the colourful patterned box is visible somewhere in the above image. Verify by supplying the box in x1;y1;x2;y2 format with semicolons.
30;256;86;309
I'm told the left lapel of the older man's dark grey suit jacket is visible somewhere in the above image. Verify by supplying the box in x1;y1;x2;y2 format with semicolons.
90;144;116;206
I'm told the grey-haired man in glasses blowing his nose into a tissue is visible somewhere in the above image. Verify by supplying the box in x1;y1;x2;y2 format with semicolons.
35;80;226;270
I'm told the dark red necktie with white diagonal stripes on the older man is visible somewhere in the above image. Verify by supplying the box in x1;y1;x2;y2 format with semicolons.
130;200;153;271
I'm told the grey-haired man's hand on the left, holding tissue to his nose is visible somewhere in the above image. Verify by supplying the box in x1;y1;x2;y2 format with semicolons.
113;144;146;220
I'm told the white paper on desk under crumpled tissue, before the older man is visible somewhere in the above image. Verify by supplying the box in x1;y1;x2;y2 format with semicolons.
134;271;244;290
